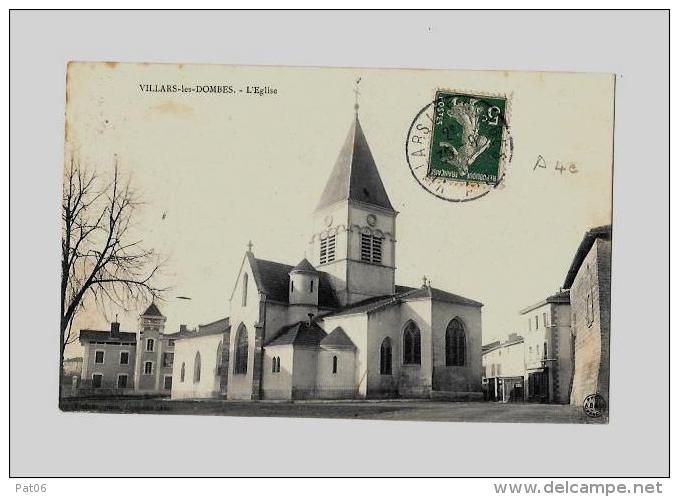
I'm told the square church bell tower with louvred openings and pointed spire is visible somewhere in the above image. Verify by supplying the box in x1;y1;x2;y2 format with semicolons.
309;95;398;305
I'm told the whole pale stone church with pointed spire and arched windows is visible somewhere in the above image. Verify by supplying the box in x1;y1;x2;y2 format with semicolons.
172;106;482;400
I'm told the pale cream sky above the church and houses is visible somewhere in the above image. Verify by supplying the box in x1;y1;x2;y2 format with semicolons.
65;63;613;355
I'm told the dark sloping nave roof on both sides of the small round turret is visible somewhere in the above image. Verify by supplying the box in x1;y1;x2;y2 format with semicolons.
248;252;339;308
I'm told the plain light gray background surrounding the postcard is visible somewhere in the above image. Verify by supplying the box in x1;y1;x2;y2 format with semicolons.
10;12;669;476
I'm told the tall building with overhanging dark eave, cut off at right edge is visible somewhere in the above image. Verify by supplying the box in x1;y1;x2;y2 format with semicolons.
563;225;612;406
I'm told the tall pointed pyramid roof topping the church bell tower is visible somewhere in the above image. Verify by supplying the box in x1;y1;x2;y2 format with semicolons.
316;115;394;211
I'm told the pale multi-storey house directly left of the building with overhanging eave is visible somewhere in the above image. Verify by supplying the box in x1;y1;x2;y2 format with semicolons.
520;290;573;404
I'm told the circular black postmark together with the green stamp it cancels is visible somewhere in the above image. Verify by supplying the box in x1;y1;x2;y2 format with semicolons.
405;90;514;202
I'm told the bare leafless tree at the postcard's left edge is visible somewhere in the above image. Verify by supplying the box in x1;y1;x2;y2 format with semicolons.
60;158;165;392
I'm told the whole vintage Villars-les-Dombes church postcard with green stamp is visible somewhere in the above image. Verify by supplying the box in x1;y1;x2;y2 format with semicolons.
55;62;615;423
